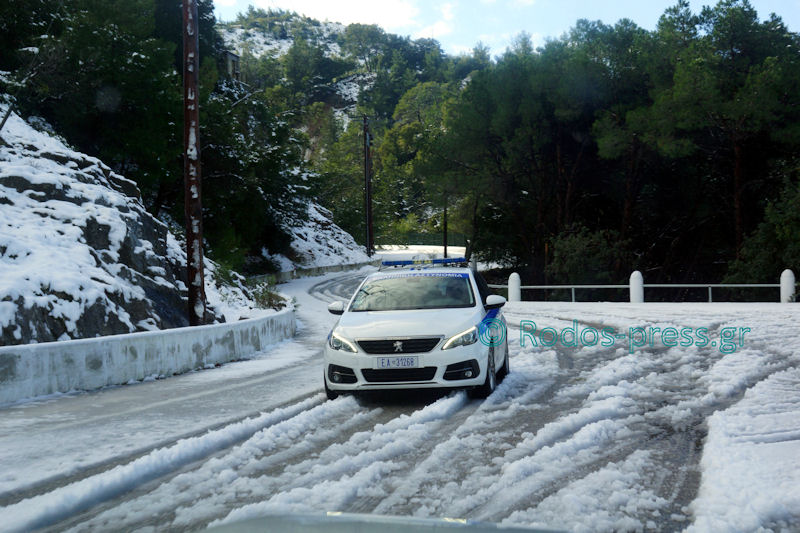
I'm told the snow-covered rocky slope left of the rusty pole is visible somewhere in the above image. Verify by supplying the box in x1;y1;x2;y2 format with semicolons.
0;106;215;345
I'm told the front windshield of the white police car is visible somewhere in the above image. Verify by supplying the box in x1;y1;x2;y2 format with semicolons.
350;273;475;311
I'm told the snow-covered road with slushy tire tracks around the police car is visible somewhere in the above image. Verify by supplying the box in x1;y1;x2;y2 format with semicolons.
0;273;800;531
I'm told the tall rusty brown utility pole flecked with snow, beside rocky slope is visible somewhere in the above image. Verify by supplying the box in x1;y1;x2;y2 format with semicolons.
183;0;206;326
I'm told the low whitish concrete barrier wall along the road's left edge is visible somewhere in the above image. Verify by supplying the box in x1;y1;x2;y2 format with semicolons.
0;309;295;405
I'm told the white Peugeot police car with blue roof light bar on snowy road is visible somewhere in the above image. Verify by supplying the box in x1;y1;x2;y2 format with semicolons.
324;258;509;399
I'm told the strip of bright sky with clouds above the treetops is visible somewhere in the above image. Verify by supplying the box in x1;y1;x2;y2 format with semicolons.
214;0;800;55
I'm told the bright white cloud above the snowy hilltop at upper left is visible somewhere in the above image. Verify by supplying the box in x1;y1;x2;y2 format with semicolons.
253;0;420;32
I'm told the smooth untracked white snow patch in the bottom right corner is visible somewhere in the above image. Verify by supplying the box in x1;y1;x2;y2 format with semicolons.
689;368;800;531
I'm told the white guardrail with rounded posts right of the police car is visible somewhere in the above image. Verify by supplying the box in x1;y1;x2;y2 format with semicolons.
489;269;796;303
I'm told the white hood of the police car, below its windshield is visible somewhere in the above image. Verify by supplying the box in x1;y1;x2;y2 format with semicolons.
334;307;484;339
